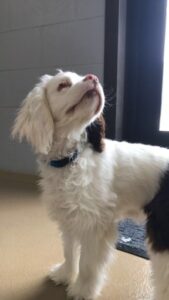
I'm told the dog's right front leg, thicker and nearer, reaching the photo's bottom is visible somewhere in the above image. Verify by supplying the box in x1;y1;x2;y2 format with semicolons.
68;231;115;300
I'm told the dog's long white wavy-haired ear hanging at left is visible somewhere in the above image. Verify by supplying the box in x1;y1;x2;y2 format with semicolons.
12;77;54;154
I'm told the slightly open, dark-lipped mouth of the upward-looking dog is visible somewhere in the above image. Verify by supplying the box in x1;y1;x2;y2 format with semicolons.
67;88;101;114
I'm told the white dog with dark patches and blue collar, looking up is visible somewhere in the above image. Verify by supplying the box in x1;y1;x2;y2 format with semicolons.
12;70;169;300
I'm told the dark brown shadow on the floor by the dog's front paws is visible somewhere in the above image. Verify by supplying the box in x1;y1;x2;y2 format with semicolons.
18;279;68;300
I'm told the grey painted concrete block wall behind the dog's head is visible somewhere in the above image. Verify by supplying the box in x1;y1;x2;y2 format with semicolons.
0;0;105;173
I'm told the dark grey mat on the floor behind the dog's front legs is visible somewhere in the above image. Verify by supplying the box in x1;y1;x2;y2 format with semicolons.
117;220;148;259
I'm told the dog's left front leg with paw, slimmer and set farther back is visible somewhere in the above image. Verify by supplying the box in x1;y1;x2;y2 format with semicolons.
49;233;80;285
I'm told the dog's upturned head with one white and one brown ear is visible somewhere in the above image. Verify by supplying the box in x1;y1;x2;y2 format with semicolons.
12;71;104;154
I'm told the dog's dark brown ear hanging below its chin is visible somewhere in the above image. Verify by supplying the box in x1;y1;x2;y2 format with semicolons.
87;115;105;152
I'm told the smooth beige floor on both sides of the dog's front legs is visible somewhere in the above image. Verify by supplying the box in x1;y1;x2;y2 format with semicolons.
0;177;151;300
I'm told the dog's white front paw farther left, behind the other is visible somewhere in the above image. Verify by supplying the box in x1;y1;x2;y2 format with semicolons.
49;263;71;285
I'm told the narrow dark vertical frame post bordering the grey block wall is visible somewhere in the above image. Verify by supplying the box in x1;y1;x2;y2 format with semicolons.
104;0;119;139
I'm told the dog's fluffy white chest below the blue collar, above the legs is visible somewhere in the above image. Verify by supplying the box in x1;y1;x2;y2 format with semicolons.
39;158;113;226
